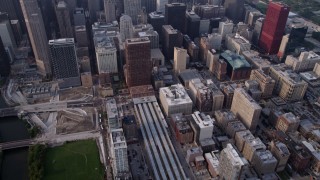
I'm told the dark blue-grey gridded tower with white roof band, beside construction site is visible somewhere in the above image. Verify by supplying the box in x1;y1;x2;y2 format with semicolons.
49;38;81;88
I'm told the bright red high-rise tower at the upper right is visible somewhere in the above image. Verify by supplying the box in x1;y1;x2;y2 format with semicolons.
259;2;290;54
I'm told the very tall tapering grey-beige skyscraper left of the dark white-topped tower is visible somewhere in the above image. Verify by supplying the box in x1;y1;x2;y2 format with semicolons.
20;0;51;75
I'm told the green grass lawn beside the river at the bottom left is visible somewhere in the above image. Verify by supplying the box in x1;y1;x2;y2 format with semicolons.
44;140;104;180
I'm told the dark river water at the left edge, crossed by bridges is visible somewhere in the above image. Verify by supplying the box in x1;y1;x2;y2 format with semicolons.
0;96;29;180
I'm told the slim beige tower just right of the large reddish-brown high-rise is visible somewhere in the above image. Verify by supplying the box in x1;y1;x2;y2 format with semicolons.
173;47;188;72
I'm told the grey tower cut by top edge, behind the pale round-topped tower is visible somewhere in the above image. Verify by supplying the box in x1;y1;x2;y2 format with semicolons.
123;0;141;24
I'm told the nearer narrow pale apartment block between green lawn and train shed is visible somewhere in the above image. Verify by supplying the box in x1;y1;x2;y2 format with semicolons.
109;128;129;177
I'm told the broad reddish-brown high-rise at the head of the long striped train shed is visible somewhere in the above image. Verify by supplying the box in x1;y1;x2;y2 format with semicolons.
125;38;152;87
